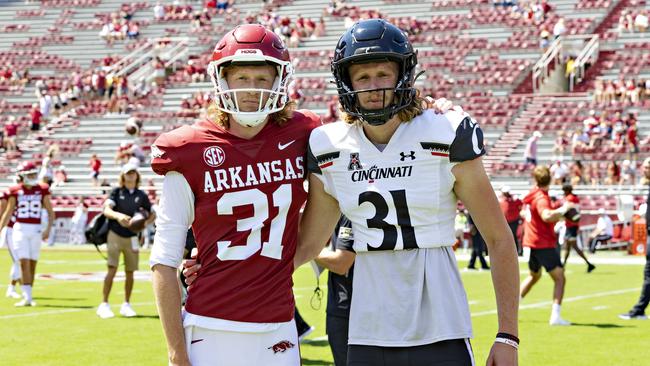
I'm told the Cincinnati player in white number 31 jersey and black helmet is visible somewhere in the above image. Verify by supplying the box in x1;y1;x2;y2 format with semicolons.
295;19;519;366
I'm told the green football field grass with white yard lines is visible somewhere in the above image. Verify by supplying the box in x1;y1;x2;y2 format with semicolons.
0;247;650;366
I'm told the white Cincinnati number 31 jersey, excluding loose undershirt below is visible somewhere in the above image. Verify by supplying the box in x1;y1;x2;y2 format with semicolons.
308;107;484;253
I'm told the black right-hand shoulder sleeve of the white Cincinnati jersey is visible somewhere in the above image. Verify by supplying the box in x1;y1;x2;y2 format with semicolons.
449;115;485;163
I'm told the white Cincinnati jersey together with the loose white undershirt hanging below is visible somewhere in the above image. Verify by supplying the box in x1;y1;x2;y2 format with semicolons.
307;111;485;347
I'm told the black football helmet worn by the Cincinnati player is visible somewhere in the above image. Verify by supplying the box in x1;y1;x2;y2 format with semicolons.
332;19;417;126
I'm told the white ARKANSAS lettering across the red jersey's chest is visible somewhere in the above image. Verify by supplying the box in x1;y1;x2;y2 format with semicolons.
203;156;305;193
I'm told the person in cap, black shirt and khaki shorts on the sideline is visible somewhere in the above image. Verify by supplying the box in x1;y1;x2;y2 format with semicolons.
97;164;156;319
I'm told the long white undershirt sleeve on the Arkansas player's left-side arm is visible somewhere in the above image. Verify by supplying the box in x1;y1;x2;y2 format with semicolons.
149;172;194;268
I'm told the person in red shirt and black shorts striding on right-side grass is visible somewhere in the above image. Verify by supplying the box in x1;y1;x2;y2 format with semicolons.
520;165;572;325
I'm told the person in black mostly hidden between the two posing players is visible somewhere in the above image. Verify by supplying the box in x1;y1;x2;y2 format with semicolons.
315;216;356;366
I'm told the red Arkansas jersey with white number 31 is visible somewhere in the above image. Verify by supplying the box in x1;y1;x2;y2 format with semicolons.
151;111;325;323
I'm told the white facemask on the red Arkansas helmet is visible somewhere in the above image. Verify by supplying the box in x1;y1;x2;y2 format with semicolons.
208;52;293;127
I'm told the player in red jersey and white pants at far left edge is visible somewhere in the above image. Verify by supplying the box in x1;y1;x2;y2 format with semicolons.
0;161;54;306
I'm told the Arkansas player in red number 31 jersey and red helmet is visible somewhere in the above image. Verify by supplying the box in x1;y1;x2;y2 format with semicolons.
151;25;316;365
